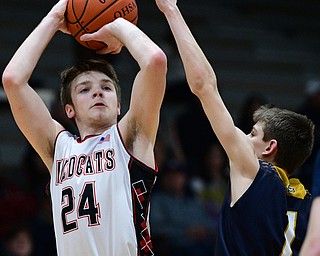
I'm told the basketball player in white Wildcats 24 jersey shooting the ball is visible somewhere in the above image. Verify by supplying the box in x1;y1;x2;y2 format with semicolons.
2;0;167;256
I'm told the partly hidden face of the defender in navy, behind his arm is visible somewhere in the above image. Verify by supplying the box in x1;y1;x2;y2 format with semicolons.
248;122;269;159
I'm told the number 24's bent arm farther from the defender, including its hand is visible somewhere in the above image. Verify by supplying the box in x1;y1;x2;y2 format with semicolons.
2;0;67;172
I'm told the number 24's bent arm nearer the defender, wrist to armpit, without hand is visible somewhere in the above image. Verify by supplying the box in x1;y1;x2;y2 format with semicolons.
117;18;167;146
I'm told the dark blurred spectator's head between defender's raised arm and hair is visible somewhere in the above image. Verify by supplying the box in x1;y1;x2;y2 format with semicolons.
237;94;267;134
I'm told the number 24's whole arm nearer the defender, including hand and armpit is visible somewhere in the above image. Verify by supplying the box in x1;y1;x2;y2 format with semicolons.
81;18;167;165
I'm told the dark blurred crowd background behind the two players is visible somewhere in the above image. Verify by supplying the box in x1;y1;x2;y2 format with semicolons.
0;0;320;256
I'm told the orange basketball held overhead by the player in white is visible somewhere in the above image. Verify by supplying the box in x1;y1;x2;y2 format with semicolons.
65;0;138;50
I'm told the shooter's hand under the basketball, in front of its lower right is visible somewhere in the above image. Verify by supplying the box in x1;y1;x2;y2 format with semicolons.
80;22;123;54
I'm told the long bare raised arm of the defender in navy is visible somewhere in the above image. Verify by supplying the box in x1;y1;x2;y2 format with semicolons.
156;0;258;182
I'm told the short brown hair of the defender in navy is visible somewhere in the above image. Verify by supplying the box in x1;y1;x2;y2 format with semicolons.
253;105;314;174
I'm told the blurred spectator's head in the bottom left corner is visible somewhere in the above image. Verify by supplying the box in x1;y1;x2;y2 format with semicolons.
1;224;34;256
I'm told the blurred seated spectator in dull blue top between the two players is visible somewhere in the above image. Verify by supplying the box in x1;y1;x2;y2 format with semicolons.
150;163;214;256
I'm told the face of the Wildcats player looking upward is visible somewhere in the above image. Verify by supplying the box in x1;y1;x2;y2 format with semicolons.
66;71;120;126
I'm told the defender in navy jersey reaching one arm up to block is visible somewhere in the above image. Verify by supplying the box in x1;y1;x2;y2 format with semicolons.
155;0;314;256
